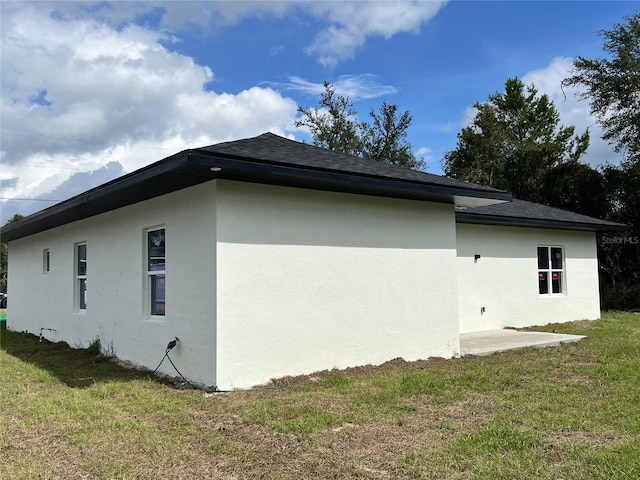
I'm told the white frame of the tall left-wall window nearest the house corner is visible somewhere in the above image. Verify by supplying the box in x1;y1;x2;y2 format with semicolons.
144;225;167;320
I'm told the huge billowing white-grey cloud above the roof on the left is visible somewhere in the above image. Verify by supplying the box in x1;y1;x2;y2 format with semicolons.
0;3;297;218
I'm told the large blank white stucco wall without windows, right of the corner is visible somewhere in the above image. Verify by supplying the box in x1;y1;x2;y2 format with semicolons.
217;181;460;389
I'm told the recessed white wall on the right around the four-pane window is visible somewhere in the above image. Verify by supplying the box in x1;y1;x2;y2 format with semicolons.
457;224;600;333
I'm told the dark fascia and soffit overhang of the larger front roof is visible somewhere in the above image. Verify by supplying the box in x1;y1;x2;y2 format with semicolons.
0;150;512;242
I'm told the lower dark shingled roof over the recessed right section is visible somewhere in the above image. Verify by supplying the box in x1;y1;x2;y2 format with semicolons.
456;198;627;232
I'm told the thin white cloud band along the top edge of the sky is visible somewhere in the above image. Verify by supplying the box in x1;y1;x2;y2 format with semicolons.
27;0;448;68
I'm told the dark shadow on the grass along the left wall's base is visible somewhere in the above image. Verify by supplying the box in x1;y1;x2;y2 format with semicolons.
0;322;165;388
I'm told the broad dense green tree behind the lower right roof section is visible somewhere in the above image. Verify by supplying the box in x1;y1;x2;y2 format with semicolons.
443;78;589;204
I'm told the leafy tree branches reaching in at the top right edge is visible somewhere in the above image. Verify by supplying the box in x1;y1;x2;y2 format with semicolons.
563;12;640;162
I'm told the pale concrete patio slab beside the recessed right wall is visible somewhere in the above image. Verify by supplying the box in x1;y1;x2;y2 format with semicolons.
460;329;586;355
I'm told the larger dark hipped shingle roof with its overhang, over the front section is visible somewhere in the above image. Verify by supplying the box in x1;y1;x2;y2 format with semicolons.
0;133;511;241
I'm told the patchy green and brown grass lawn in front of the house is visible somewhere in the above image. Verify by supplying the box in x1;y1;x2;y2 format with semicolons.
0;312;640;480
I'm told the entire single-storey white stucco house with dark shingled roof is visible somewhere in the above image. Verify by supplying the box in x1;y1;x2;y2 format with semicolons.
0;134;624;390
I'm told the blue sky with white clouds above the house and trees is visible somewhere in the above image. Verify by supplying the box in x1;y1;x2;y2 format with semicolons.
0;1;640;224
